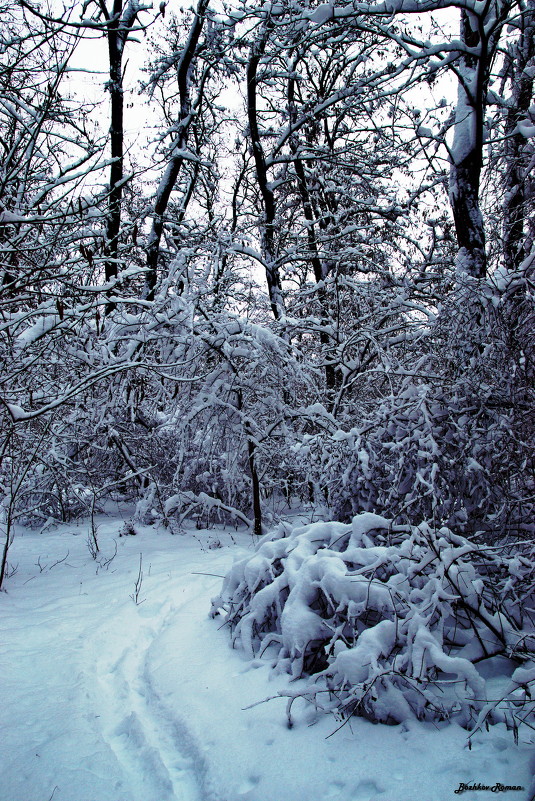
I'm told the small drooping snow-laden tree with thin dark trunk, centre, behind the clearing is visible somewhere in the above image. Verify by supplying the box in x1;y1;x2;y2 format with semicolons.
162;313;316;533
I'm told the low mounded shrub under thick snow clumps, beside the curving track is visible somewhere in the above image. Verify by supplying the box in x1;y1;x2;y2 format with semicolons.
212;513;535;728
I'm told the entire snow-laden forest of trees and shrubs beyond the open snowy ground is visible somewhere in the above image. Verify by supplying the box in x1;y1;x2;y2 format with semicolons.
0;0;535;801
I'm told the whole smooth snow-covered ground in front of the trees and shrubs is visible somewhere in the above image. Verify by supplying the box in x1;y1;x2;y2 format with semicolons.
0;518;533;801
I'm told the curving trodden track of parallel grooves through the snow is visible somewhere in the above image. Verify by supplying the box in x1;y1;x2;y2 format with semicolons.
85;588;215;801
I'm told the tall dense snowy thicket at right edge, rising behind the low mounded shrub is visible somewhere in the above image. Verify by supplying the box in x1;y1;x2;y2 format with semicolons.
324;279;535;538
